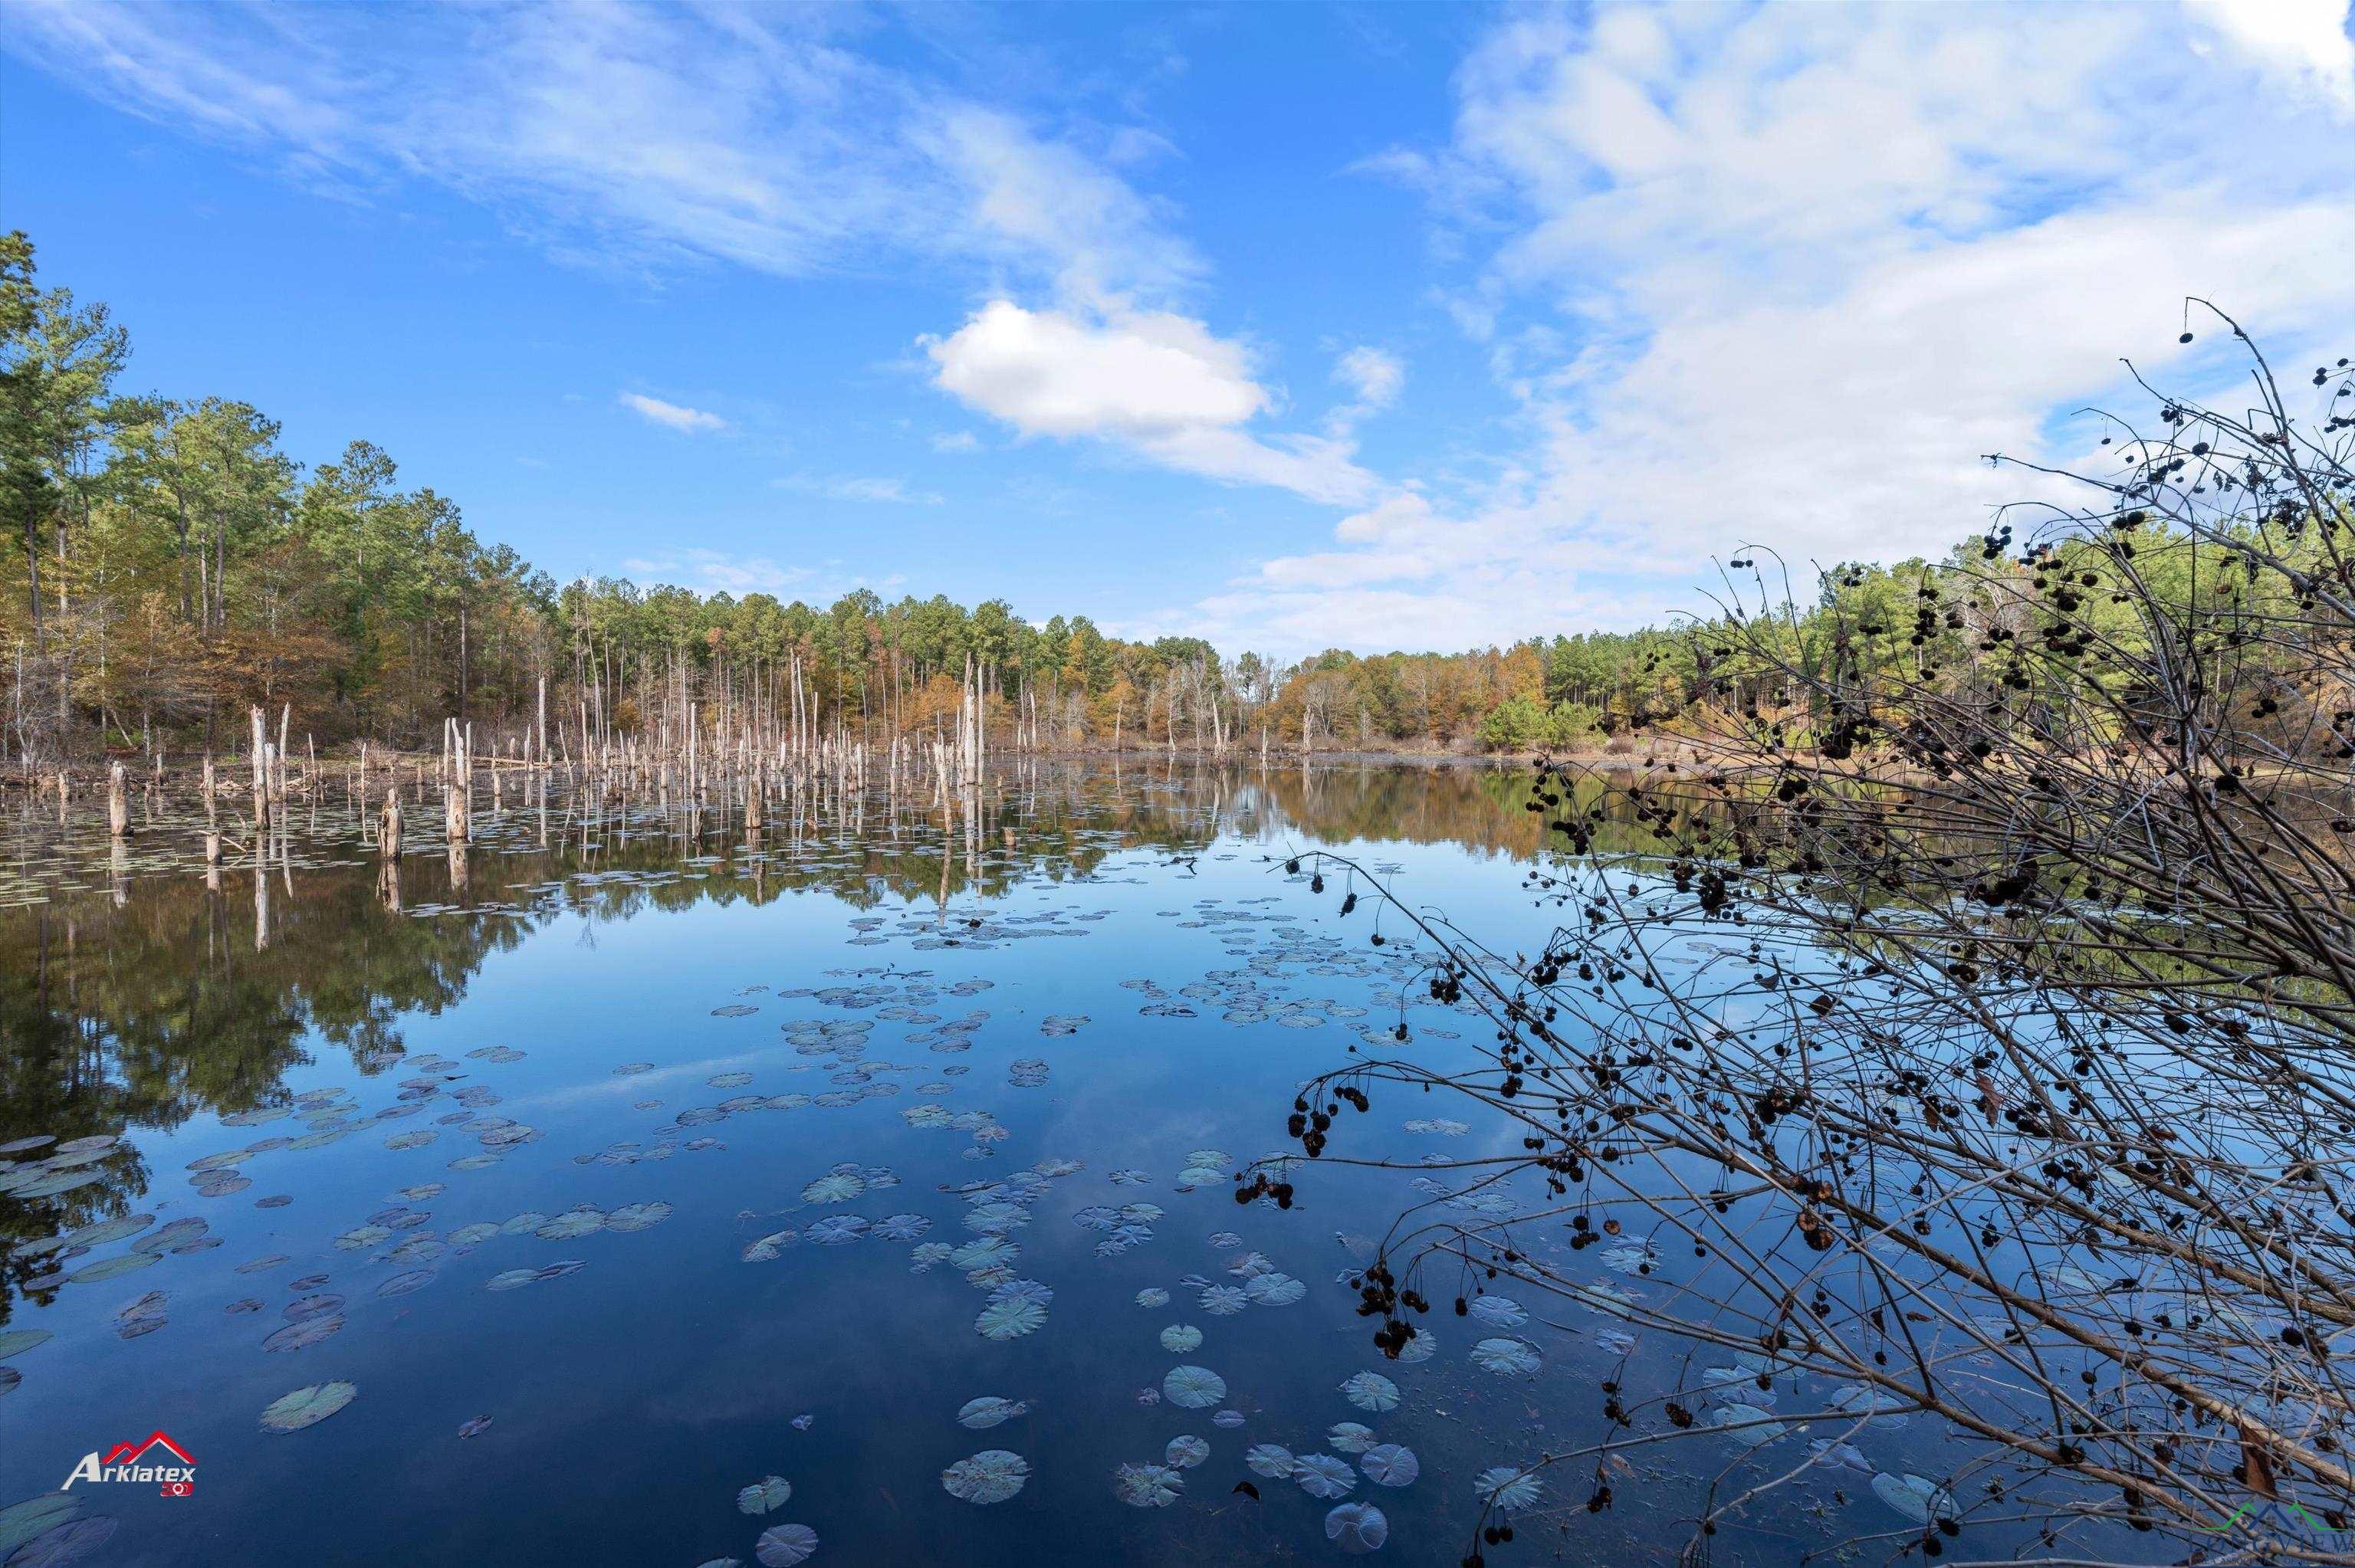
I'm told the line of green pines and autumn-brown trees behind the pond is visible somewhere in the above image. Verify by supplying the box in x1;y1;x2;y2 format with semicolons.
0;233;2336;767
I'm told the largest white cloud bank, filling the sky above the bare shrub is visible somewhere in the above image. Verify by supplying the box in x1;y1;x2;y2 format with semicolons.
1194;2;2355;645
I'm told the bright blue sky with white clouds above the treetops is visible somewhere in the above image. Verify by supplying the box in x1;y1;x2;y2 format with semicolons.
0;0;2355;654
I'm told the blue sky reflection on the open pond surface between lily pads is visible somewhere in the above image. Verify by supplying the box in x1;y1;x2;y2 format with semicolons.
0;779;2006;1568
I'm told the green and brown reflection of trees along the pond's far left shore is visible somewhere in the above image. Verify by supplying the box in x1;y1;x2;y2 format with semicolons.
0;763;1639;1295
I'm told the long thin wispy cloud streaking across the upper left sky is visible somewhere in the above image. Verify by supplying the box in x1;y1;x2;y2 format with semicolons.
0;0;1201;308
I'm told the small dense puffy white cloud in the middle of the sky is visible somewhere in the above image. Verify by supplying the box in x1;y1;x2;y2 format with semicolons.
921;299;1375;504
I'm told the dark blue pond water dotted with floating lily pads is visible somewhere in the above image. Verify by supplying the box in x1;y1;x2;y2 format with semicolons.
0;767;1959;1568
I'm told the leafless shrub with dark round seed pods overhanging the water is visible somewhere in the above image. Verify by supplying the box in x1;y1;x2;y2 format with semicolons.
1239;310;2355;1563
